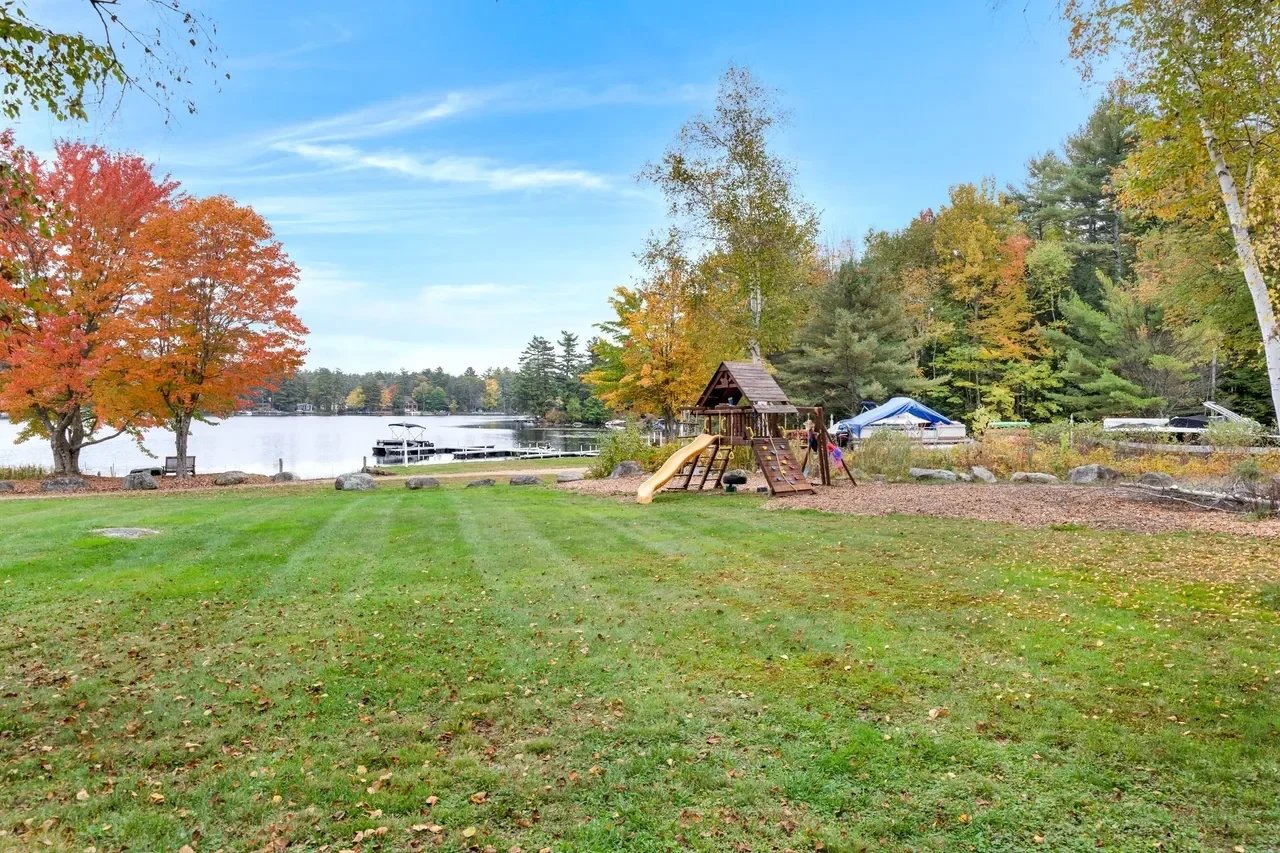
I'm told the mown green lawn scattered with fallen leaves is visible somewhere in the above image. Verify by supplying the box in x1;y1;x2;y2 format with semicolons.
0;485;1280;852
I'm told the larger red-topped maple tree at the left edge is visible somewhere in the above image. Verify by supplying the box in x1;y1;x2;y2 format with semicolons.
0;136;177;474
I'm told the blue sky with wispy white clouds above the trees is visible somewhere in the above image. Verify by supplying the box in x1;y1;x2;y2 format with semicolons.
19;0;1098;370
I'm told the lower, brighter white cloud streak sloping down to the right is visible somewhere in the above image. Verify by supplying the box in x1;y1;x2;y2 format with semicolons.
275;142;608;190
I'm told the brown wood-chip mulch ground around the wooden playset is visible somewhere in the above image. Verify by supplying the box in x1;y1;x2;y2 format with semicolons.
561;476;1280;538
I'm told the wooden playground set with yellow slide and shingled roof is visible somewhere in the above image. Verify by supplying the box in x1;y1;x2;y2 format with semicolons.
636;361;856;503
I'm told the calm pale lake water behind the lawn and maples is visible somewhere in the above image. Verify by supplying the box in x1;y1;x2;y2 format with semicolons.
0;415;600;478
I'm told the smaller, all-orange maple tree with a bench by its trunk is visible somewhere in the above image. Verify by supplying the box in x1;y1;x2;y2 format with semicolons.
127;196;307;476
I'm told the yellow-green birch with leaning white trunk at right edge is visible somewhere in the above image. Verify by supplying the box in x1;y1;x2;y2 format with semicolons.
1064;0;1280;420
